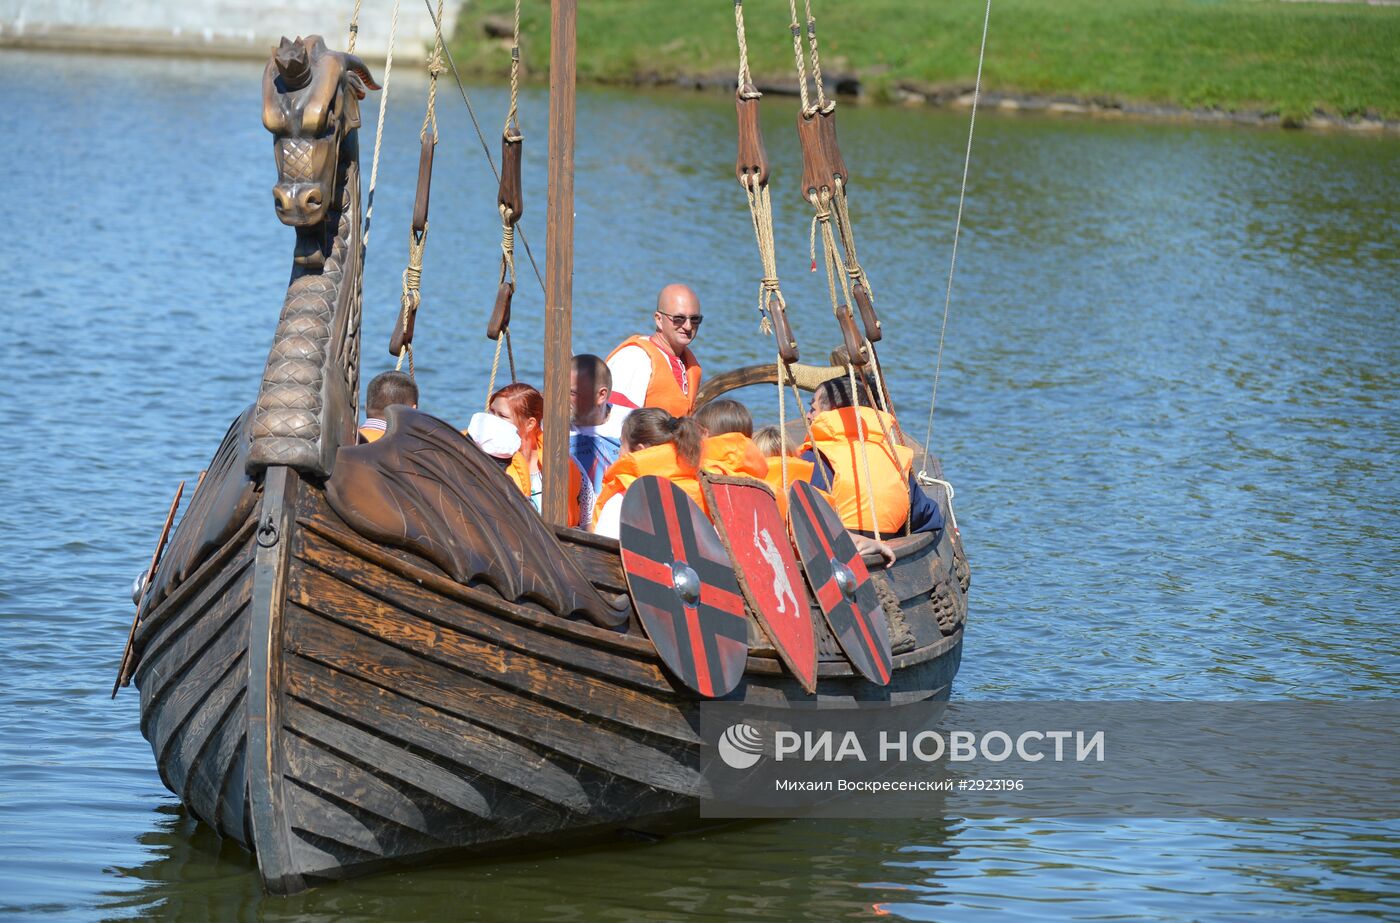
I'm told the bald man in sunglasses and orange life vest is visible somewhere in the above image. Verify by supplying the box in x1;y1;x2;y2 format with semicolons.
608;283;704;416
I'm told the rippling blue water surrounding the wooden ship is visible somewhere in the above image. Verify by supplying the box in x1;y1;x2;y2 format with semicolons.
0;53;1400;920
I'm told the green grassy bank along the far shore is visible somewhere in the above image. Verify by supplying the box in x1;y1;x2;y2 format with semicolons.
454;0;1400;123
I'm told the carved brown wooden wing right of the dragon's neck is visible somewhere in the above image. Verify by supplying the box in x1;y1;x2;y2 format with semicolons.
326;406;629;627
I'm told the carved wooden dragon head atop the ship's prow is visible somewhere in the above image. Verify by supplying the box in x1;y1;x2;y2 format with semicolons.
263;35;379;227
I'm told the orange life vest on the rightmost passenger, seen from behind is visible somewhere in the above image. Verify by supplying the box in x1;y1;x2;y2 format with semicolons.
804;408;914;535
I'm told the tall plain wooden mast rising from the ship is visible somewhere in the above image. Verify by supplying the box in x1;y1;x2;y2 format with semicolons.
540;0;577;525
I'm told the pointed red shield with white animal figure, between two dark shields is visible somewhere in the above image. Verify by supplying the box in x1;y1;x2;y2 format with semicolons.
700;475;816;693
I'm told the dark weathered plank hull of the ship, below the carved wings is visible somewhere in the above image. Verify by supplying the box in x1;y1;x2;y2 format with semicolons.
134;426;966;894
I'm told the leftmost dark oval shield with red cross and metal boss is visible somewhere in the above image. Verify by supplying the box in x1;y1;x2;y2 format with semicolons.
619;475;749;698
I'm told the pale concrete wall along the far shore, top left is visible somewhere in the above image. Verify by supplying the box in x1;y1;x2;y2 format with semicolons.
0;0;458;62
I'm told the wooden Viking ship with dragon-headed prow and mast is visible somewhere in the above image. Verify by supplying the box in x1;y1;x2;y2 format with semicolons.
120;1;967;894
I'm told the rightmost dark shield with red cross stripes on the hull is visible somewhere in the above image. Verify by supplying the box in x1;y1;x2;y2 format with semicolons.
788;480;893;686
